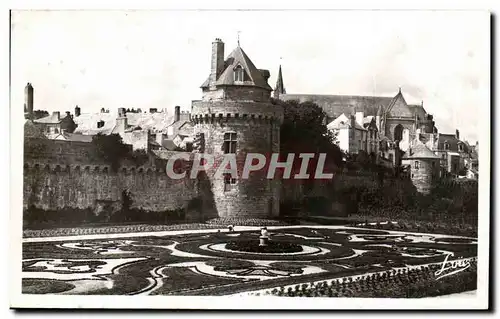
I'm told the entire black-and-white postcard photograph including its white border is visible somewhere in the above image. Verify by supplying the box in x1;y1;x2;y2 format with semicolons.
10;9;493;309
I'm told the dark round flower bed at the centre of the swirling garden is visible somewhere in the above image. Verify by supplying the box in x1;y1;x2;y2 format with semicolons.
226;240;303;254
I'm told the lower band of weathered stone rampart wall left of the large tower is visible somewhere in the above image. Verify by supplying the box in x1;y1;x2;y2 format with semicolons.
23;164;197;211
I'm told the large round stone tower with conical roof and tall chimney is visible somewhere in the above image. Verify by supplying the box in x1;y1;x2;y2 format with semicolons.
191;39;283;218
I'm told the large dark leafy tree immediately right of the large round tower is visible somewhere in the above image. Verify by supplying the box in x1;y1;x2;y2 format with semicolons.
272;100;343;177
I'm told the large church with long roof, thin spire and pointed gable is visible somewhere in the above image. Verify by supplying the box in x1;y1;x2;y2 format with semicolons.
274;66;437;166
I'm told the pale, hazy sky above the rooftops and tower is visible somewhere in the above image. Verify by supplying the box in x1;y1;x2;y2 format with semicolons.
11;11;490;142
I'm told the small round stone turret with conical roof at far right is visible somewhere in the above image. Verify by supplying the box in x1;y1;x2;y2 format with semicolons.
407;140;439;194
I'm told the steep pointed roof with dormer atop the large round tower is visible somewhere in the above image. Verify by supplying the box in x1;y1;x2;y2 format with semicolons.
201;46;272;91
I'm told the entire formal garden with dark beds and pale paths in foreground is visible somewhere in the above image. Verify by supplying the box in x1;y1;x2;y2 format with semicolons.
22;226;477;298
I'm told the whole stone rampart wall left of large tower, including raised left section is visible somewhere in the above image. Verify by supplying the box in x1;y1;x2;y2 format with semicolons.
23;140;203;218
